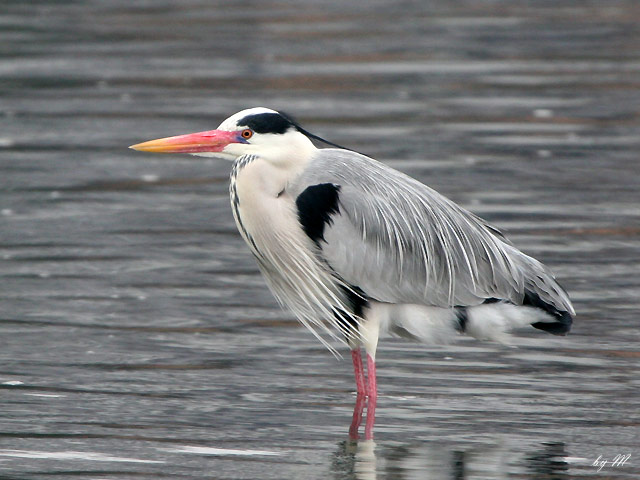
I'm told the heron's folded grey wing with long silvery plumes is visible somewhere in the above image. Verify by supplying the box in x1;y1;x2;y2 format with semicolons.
292;149;573;313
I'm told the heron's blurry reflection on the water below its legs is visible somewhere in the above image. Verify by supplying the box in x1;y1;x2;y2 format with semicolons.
329;440;571;480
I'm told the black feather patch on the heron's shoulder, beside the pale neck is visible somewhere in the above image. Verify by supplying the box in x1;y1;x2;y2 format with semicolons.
296;183;340;245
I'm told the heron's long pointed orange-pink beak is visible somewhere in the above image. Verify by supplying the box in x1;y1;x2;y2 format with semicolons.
129;130;245;153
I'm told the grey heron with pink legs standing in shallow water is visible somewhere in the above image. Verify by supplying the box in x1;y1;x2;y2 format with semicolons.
131;107;574;437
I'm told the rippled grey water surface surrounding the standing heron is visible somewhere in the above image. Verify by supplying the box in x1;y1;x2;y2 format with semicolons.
0;0;640;480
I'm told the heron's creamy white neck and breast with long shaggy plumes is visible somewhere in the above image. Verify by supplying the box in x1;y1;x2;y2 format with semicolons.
231;157;360;349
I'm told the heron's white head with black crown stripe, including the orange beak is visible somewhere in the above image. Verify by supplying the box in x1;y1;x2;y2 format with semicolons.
129;107;315;163
